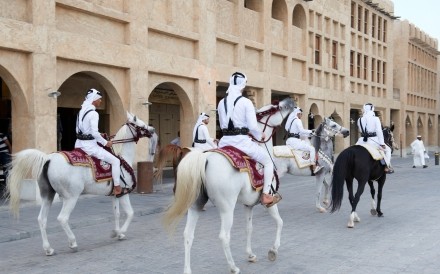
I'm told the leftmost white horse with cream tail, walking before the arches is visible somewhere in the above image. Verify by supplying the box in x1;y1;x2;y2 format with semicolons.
7;113;157;256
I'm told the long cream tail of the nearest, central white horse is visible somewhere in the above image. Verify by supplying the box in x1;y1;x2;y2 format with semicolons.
163;150;207;233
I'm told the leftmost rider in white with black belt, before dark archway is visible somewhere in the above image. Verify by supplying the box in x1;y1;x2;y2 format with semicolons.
75;88;122;195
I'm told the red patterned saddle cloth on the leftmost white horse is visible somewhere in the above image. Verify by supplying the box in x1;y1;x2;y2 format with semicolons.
58;148;112;182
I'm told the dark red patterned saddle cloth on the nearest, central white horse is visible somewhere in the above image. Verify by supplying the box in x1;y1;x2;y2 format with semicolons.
210;146;264;191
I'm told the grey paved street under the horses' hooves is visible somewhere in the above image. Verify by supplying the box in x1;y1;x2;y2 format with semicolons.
0;155;440;274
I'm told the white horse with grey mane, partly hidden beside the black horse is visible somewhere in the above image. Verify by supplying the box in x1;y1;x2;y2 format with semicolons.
274;118;350;212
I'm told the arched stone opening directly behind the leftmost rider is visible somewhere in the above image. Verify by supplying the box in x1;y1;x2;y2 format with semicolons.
57;70;127;150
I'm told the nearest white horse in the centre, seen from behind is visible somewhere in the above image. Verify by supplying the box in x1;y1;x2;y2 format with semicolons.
164;98;295;273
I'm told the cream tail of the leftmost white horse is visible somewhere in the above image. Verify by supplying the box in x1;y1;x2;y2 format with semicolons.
6;149;49;217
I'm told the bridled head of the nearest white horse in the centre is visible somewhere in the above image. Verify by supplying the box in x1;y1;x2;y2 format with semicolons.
257;97;295;128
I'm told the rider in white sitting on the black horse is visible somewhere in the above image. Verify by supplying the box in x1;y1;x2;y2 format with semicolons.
356;103;394;174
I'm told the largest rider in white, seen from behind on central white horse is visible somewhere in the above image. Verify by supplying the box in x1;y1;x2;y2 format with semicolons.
217;72;274;205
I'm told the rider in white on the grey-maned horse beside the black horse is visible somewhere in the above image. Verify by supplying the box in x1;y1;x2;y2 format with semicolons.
285;107;321;173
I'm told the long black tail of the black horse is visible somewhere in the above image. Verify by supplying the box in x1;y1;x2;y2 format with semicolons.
330;148;354;213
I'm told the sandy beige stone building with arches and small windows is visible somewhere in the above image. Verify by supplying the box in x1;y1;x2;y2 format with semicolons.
0;0;440;197
